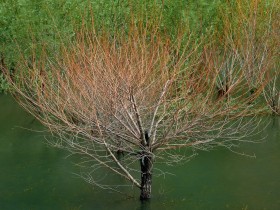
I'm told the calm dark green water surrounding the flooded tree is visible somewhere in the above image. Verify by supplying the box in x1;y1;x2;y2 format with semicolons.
0;95;280;210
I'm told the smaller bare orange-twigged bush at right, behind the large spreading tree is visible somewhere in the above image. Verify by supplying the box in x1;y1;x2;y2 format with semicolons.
219;0;280;109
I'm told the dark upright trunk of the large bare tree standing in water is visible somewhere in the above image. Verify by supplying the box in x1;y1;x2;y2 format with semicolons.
140;131;153;201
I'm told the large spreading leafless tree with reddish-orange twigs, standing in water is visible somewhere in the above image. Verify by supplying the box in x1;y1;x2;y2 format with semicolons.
8;21;264;200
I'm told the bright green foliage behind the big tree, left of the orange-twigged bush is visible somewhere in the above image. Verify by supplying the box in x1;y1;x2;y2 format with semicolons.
0;0;223;58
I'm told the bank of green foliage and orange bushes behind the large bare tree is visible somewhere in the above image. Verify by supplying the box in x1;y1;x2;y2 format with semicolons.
0;0;280;115
